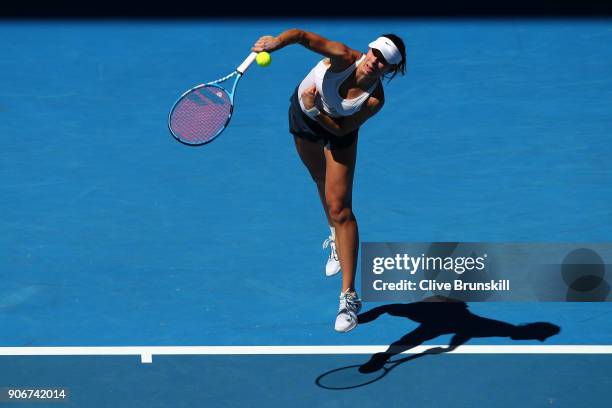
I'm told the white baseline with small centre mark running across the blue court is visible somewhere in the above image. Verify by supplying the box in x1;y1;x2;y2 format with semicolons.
0;344;612;363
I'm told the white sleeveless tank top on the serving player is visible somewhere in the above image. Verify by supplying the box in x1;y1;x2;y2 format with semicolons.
298;54;378;118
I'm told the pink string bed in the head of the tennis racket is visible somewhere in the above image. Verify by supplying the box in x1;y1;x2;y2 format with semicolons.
170;85;232;145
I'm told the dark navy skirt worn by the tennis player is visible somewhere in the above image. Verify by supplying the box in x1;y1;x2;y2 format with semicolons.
289;88;359;150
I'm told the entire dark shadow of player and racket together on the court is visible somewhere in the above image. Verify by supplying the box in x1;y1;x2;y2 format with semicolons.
315;296;561;389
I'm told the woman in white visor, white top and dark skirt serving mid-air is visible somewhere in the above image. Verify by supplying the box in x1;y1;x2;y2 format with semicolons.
252;29;406;332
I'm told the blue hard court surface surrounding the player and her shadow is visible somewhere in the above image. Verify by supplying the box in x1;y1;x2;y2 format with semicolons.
0;19;612;407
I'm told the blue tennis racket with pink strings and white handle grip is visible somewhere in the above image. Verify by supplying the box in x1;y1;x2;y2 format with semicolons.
168;52;257;146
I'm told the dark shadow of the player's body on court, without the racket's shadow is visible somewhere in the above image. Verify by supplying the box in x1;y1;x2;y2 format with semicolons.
358;296;561;373
